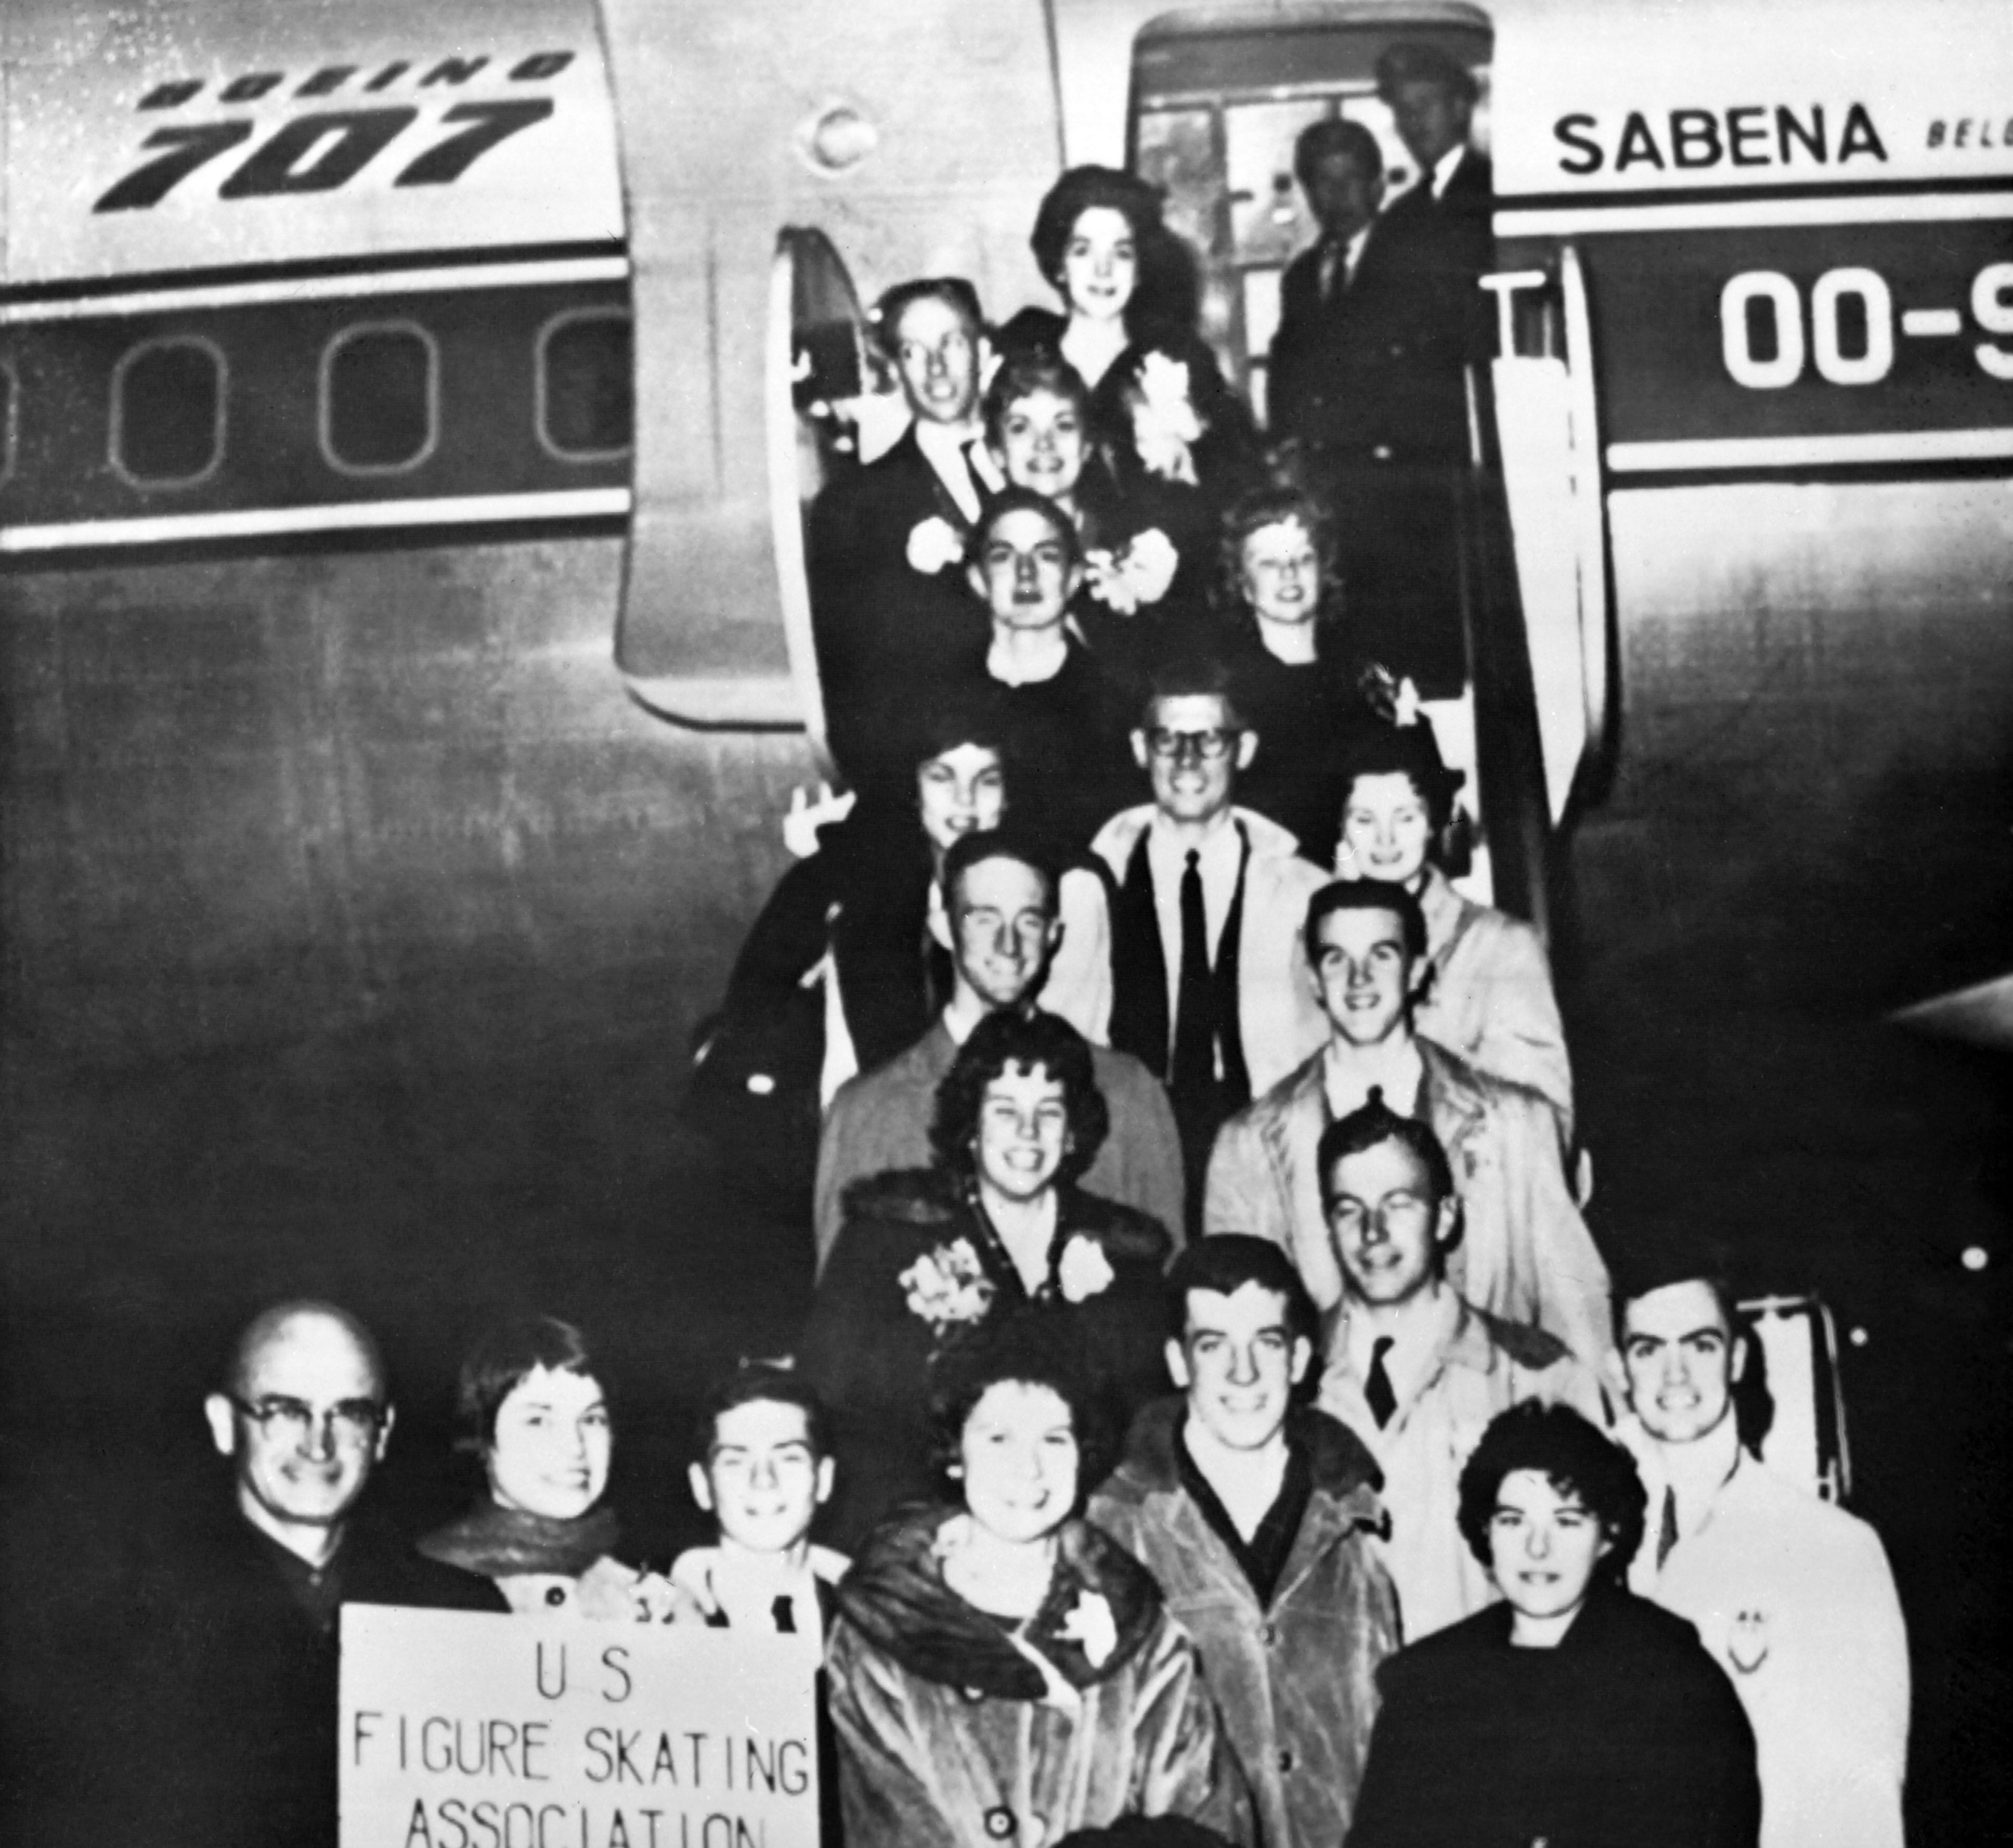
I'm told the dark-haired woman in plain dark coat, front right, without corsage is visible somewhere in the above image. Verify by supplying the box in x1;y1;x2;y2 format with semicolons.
1349;1401;1761;1848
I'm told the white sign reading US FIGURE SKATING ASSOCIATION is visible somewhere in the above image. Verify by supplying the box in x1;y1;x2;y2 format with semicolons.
338;1605;817;1848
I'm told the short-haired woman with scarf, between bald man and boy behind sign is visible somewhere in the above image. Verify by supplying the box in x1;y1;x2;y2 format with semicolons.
419;1314;672;1623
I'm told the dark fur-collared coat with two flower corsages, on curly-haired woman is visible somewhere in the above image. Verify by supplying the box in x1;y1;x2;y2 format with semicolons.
797;1168;1174;1552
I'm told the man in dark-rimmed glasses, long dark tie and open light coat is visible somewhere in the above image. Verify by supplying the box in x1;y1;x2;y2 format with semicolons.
1091;660;1327;1230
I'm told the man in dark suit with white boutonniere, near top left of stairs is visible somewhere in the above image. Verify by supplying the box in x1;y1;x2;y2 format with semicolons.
809;276;998;781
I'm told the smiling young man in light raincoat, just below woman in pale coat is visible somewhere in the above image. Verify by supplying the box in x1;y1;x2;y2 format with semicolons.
1200;880;1611;1365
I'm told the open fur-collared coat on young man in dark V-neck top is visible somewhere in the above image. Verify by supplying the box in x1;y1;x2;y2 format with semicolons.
1091;1399;1399;1848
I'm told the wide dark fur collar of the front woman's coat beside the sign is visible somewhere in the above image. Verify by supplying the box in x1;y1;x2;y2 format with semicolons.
837;1506;1162;1701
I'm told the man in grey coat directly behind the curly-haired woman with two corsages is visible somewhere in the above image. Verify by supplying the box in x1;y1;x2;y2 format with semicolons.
813;821;1184;1268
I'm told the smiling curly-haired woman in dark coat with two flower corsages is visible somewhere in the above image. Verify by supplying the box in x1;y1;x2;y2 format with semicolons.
797;1006;1172;1552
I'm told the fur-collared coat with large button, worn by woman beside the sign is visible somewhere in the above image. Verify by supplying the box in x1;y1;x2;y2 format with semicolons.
827;1508;1250;1848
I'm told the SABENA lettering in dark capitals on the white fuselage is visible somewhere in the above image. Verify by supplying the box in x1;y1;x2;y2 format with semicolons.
1552;102;1884;177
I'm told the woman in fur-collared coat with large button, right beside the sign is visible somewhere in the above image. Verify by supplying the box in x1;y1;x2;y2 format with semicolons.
827;1309;1250;1848
